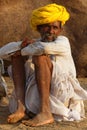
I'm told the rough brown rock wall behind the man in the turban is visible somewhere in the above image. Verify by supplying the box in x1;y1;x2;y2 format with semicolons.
0;0;87;77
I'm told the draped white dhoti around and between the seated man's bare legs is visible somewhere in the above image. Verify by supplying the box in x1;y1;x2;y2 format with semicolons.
9;59;87;121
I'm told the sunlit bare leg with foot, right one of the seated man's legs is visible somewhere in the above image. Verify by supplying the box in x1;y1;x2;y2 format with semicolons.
23;55;54;126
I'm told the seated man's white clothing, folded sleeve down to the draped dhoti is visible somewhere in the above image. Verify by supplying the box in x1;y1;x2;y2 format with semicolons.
2;36;87;121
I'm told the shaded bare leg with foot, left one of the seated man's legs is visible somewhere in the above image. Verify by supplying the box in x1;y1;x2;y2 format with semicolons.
8;55;25;123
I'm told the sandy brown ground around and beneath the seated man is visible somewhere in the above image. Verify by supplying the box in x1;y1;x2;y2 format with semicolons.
0;77;87;130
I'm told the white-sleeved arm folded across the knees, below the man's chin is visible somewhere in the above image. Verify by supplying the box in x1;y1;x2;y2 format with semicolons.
21;37;71;55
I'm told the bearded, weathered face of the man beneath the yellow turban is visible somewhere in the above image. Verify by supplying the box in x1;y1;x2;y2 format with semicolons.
39;21;61;42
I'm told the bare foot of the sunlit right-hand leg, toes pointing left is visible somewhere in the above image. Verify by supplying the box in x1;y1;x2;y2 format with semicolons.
22;113;54;126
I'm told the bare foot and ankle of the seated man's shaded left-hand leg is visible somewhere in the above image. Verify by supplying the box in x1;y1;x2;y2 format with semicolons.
7;100;25;123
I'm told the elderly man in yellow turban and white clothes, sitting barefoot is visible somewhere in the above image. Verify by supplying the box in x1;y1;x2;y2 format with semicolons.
1;4;87;126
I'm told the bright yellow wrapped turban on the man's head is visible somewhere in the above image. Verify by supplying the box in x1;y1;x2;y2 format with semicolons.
31;3;69;30
